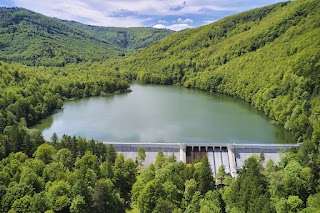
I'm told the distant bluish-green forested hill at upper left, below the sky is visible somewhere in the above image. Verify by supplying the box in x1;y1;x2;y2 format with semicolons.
0;8;172;66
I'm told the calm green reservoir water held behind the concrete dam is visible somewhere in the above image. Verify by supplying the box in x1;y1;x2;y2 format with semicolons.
35;84;294;144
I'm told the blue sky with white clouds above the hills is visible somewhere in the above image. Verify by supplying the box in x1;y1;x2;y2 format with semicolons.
0;0;284;31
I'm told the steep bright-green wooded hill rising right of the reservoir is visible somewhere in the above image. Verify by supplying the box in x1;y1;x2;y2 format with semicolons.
116;0;320;141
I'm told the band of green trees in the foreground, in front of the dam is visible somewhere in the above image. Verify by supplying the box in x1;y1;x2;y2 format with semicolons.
0;135;320;213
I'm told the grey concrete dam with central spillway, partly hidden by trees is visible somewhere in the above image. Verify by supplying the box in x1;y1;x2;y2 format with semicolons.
104;142;301;177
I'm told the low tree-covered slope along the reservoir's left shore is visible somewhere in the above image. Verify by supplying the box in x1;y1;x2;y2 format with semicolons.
0;62;129;158
